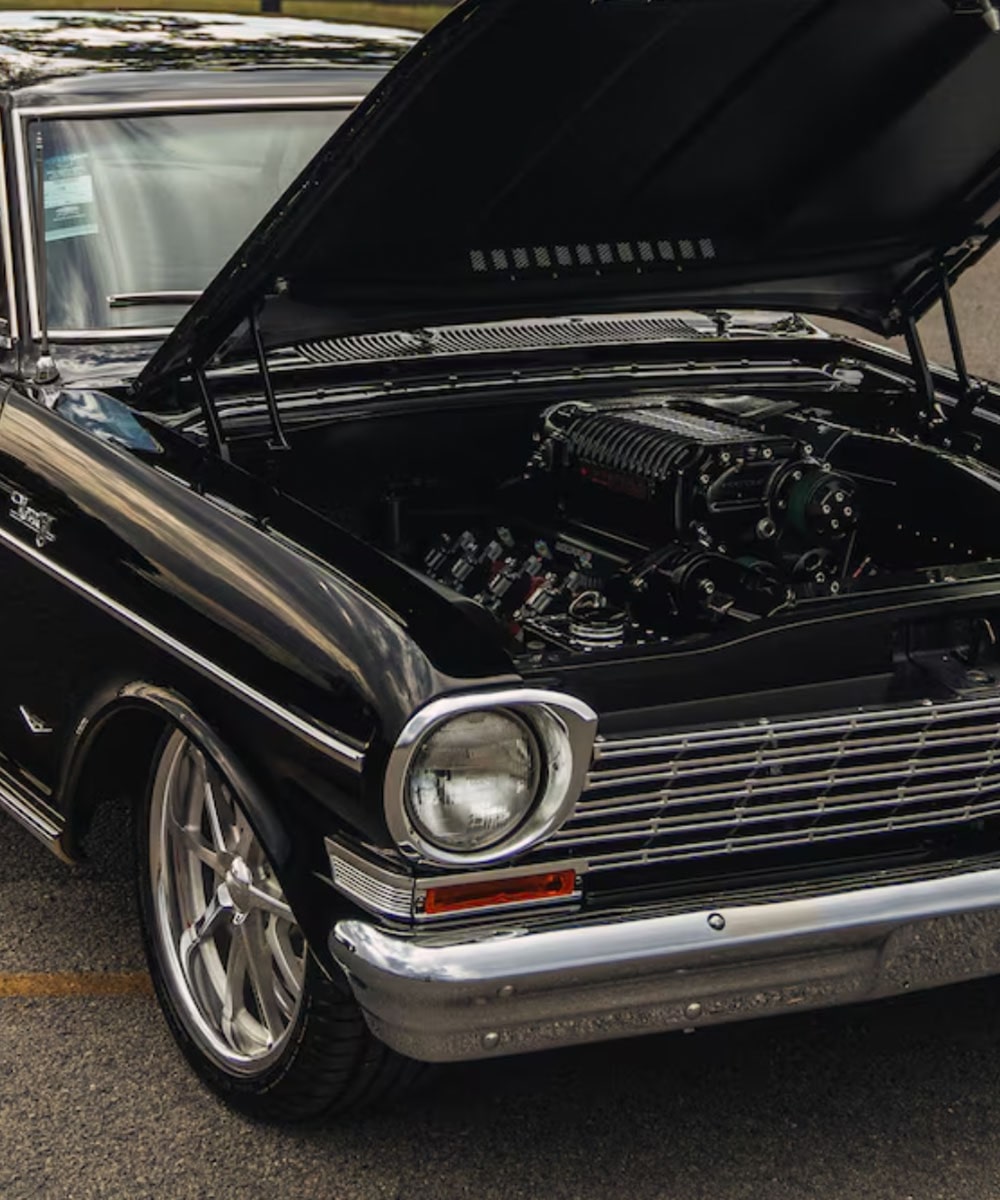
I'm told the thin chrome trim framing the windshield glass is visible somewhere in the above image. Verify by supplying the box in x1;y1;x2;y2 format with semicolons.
14;95;365;342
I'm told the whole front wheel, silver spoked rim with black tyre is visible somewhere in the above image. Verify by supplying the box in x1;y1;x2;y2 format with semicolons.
136;730;420;1122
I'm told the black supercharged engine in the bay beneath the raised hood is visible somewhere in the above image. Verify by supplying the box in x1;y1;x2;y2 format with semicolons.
396;395;1000;653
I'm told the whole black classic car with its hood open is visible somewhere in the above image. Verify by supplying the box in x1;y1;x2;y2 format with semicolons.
0;0;1000;1121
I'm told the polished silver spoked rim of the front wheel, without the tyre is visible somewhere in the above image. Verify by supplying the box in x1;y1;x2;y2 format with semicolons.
149;731;306;1076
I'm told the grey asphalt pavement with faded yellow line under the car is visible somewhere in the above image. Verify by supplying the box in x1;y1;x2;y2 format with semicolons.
0;248;1000;1200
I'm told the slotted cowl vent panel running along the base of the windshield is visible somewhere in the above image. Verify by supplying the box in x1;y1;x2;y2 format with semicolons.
286;313;814;362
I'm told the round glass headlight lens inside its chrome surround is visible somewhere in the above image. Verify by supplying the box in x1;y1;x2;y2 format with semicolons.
406;709;541;852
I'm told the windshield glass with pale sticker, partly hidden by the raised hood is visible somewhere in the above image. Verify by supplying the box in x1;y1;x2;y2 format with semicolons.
28;108;347;332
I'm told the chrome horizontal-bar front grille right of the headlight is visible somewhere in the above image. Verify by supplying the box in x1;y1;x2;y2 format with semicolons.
546;696;1000;870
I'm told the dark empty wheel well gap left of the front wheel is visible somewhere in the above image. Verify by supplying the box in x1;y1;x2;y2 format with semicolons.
64;706;173;862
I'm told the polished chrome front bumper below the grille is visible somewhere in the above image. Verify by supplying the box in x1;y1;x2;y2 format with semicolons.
330;870;1000;1062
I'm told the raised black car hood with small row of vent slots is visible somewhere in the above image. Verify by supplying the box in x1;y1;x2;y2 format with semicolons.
140;0;1000;383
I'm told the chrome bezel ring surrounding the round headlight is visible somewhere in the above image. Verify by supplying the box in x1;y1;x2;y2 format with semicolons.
384;688;597;866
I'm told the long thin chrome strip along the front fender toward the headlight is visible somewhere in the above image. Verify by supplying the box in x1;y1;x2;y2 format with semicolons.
0;528;365;773
